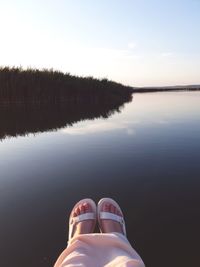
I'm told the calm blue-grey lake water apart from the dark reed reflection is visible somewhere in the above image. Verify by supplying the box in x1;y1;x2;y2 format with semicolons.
0;92;200;267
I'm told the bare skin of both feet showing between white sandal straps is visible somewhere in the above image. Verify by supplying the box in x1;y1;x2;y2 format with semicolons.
72;202;123;240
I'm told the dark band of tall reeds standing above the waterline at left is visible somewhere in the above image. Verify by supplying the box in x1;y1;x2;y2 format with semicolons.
0;67;133;105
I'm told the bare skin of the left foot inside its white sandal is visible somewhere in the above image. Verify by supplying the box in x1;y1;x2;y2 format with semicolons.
72;202;95;240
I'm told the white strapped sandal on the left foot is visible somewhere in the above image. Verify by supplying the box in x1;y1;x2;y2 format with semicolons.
68;198;96;240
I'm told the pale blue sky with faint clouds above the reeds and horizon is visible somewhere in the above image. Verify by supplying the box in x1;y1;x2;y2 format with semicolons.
0;0;200;86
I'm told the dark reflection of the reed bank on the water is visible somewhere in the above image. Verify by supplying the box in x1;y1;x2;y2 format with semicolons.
0;97;132;139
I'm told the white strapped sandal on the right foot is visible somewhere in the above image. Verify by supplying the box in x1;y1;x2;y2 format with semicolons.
97;198;126;236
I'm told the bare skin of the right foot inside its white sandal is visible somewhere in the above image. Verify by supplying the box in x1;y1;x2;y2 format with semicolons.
101;202;124;234
